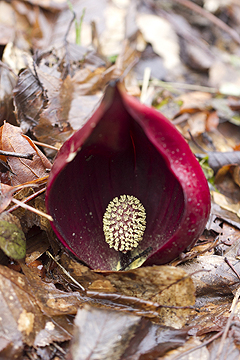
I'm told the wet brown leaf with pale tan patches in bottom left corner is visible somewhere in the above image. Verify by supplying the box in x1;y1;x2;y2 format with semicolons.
0;266;72;359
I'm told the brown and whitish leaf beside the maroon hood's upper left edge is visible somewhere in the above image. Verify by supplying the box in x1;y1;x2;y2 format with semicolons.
34;66;114;146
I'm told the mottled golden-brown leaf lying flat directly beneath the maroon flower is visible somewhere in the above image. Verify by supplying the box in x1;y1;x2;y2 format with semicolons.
59;253;195;328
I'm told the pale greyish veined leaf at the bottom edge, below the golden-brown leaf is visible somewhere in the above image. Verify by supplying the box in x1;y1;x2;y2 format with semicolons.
71;305;188;360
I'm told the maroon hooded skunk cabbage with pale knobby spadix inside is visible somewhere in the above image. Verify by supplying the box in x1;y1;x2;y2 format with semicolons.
46;83;210;270
